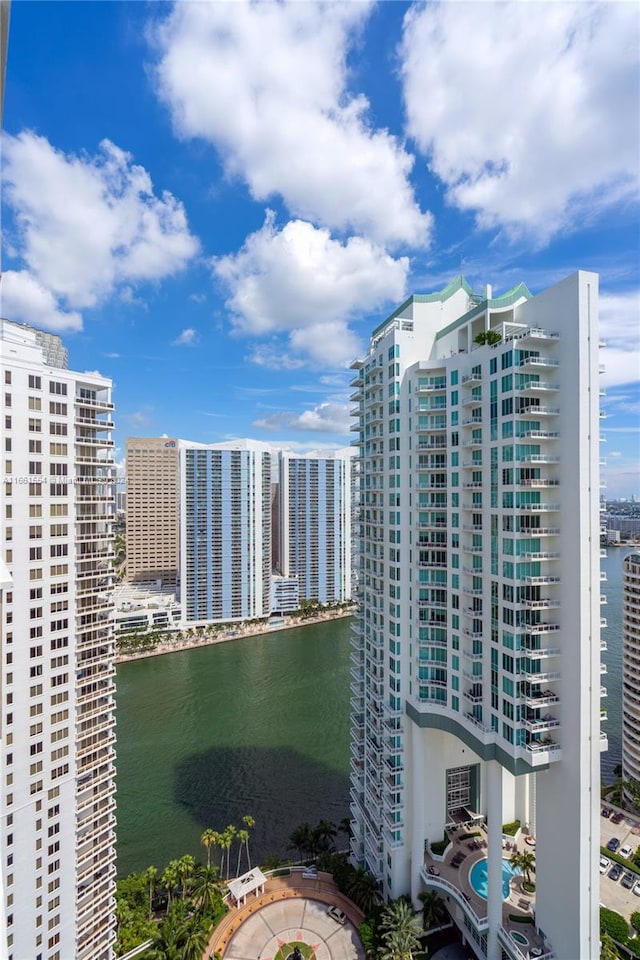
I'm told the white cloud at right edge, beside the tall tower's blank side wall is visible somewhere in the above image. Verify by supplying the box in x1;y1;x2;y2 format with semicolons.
600;290;640;387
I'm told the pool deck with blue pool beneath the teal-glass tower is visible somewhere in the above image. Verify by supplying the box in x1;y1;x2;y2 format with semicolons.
423;827;546;960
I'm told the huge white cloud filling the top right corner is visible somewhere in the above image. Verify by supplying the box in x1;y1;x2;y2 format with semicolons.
400;2;640;241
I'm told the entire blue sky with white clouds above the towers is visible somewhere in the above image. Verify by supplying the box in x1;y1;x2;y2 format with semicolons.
2;0;640;496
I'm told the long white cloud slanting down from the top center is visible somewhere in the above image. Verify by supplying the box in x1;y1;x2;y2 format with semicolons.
155;2;432;245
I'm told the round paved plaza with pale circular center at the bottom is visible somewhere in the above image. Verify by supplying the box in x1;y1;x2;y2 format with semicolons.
204;872;364;960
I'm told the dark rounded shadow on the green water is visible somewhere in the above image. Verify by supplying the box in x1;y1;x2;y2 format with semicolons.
172;747;349;867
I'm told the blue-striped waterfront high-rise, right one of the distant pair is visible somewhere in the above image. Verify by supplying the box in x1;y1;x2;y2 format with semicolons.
279;451;351;603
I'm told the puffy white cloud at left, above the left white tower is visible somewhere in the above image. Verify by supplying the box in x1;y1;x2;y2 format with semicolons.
3;131;198;326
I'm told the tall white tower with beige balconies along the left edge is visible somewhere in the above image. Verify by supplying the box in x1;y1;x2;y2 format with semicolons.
0;320;115;960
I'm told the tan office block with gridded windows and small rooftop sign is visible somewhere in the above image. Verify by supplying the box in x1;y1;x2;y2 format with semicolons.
125;437;180;590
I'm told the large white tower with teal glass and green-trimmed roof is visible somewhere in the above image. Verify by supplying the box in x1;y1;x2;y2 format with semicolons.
351;273;602;960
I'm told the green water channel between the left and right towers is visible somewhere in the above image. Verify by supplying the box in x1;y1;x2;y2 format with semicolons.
117;618;350;876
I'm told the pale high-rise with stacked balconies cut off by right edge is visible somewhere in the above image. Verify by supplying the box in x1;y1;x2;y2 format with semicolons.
622;553;640;803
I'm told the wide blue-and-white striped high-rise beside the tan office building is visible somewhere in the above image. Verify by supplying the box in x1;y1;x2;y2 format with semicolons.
180;440;271;624
